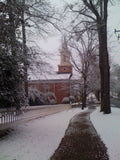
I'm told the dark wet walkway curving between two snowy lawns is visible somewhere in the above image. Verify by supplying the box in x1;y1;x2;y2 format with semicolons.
50;107;109;160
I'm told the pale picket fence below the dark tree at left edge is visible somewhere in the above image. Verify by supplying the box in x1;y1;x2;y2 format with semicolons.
0;110;21;124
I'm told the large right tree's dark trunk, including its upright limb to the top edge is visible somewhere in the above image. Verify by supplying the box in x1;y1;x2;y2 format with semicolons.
97;0;111;114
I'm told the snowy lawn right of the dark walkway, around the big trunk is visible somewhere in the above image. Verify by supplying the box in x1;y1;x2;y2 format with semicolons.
91;108;120;160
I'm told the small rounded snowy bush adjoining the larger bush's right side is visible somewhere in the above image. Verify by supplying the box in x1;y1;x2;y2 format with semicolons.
45;92;57;104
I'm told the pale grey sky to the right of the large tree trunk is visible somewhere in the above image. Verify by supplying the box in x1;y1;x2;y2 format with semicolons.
108;2;120;65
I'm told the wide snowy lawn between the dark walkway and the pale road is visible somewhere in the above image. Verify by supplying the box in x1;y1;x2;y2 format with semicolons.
0;108;85;160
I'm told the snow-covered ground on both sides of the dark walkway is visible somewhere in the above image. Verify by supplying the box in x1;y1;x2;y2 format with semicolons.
0;108;120;160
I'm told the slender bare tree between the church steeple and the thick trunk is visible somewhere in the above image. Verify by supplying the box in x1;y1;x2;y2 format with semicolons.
70;30;99;109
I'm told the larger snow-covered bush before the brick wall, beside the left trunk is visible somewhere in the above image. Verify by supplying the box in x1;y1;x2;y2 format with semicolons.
28;87;45;106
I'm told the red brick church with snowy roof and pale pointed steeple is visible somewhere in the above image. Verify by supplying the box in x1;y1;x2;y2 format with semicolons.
28;38;79;104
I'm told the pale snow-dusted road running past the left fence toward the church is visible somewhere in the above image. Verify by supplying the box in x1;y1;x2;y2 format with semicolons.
0;104;69;131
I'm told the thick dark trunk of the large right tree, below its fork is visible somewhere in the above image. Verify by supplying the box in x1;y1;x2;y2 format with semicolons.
98;22;111;114
